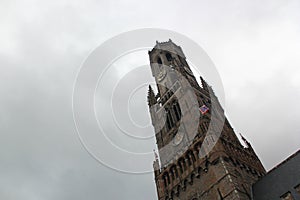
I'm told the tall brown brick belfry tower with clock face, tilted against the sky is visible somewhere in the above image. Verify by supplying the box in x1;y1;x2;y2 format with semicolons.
148;40;265;200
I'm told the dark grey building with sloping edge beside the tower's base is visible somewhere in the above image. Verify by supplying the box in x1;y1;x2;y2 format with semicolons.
252;150;300;200
